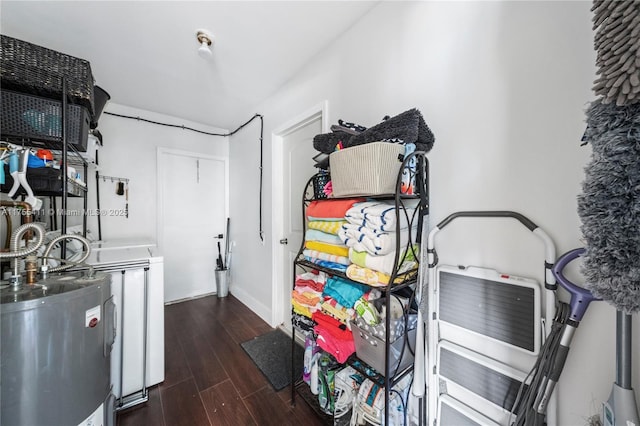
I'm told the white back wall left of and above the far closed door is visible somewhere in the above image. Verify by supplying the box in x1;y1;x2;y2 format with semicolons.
88;102;229;243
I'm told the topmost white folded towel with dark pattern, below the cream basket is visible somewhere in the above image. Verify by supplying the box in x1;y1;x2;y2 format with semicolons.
345;201;415;232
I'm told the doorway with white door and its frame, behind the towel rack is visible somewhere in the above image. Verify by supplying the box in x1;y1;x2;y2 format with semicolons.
271;101;329;330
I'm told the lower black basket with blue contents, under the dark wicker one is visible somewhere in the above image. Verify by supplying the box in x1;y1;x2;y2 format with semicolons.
0;90;89;152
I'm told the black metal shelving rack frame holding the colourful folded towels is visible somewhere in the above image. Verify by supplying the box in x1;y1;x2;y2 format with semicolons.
291;151;429;424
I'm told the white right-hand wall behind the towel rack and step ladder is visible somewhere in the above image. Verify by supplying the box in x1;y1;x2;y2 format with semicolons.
230;1;640;425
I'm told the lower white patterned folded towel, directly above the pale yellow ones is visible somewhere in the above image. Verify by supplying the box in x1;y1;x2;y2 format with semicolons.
338;223;416;255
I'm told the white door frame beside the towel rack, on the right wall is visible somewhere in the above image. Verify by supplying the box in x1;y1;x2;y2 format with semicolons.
271;100;329;327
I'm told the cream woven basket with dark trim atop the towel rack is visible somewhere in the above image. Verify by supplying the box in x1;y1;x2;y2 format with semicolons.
329;142;405;197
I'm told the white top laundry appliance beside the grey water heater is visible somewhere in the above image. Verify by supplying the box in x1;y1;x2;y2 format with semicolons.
86;240;164;410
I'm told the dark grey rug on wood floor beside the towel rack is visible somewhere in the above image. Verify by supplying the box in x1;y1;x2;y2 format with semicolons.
240;329;304;391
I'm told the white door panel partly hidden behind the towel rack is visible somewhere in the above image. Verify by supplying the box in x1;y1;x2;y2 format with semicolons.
280;116;322;329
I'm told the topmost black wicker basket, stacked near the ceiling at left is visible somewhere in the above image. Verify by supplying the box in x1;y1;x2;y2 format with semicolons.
0;35;95;114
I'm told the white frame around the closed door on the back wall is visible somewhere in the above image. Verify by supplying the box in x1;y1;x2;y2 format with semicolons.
156;147;229;278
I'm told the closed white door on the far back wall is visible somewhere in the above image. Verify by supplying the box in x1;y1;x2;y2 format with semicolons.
158;149;228;302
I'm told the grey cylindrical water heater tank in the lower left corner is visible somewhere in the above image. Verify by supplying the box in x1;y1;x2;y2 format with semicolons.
0;273;115;426
